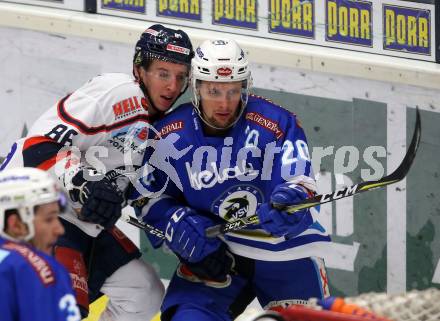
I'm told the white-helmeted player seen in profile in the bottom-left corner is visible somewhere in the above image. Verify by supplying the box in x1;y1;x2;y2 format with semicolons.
0;168;81;321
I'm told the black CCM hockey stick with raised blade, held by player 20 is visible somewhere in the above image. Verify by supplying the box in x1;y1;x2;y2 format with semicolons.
206;108;422;237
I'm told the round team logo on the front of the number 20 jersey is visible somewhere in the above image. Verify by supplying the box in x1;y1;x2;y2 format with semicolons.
212;185;263;221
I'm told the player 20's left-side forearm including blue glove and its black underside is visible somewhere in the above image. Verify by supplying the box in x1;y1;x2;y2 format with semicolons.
132;145;233;282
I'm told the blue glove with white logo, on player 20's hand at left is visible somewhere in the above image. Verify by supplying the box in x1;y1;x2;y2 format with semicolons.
165;207;222;262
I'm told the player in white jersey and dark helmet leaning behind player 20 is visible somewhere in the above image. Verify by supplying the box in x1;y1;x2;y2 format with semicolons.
1;24;194;321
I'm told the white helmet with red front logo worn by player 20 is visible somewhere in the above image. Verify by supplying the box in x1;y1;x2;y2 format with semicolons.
190;39;252;129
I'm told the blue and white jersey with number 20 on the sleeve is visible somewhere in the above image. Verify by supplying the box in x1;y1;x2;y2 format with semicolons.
137;96;330;261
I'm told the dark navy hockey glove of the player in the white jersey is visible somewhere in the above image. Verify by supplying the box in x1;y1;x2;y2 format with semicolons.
69;169;124;229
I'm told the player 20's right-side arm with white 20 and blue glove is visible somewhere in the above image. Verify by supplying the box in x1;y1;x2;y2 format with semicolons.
257;115;316;238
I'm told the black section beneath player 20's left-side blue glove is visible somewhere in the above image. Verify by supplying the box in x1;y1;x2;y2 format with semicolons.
181;243;235;284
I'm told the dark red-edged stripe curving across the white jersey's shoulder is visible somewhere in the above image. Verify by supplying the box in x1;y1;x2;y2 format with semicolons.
57;95;149;135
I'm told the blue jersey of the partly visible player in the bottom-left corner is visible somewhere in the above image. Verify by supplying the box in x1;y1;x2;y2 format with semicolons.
0;237;81;321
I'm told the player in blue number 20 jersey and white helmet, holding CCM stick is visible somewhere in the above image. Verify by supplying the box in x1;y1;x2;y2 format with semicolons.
136;40;330;321
